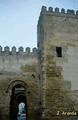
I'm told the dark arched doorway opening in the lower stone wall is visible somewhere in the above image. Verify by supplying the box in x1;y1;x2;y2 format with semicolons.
10;84;27;120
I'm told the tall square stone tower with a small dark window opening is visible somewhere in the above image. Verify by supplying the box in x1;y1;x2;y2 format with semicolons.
37;6;78;120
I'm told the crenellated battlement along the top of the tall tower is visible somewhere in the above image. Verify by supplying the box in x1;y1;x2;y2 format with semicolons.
41;6;78;16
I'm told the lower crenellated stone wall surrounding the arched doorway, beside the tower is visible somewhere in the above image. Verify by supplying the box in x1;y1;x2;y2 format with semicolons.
0;47;40;120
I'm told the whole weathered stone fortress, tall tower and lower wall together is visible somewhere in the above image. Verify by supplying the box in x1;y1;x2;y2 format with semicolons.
0;6;78;120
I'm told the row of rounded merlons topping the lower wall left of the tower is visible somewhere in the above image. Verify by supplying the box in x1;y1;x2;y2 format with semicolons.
0;46;37;56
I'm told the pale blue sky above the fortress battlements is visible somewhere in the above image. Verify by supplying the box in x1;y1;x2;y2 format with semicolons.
0;0;78;48
